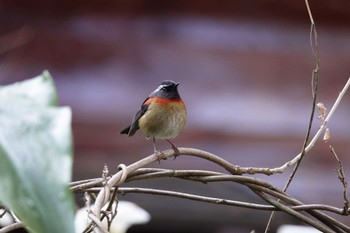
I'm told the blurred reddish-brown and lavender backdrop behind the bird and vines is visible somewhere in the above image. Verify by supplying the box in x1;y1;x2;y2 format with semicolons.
0;0;350;233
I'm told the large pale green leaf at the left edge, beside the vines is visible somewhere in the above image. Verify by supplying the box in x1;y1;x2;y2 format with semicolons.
0;71;74;233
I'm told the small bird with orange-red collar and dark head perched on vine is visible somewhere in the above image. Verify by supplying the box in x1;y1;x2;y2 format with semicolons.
120;80;187;158
